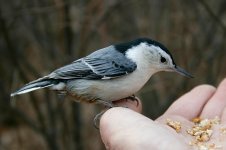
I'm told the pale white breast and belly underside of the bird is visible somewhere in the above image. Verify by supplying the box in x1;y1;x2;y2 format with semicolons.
67;67;154;101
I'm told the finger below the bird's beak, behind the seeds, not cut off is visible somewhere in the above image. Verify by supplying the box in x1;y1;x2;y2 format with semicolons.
164;85;216;120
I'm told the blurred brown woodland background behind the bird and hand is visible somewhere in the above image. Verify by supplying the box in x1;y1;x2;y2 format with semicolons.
0;0;226;150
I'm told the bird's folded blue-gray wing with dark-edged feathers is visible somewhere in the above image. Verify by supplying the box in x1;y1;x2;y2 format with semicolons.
49;47;137;80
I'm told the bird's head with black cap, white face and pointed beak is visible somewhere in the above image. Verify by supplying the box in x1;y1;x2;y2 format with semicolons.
116;38;193;78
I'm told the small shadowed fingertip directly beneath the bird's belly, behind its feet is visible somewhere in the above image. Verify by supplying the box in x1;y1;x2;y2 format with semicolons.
113;97;142;113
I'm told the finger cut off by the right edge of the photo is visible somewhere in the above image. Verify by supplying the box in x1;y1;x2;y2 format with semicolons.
201;79;226;118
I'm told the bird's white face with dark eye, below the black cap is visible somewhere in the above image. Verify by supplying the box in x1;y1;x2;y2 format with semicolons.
127;43;175;72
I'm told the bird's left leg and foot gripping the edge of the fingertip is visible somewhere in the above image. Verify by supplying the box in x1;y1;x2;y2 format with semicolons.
93;99;115;129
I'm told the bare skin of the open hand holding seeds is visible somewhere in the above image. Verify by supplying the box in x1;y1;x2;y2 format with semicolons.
100;79;226;150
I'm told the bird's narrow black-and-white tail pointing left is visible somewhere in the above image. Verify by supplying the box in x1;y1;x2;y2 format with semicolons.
10;77;59;97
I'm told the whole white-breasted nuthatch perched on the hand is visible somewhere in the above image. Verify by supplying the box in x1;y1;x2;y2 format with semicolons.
11;38;192;107
